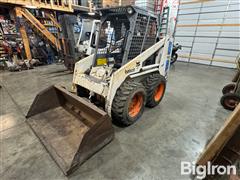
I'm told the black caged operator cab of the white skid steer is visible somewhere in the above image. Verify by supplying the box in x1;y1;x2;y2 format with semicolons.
93;6;157;69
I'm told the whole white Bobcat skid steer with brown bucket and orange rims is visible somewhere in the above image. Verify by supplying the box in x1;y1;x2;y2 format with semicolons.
27;6;172;175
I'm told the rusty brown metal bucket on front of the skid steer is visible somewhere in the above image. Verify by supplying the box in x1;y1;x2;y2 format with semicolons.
27;86;114;175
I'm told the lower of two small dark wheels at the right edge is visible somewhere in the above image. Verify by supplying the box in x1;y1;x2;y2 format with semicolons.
221;93;240;111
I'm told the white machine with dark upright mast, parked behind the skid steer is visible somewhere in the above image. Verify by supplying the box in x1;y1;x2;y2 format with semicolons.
59;14;100;71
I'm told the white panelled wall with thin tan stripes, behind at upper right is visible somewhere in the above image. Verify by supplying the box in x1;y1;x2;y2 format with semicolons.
175;0;240;67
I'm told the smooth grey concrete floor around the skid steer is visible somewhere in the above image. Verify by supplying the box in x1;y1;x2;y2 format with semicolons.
0;62;234;180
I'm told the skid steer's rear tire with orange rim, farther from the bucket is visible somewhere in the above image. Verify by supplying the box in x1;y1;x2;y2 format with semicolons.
143;73;166;108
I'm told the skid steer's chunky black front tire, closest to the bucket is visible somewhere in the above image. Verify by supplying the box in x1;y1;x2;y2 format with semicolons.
112;81;146;126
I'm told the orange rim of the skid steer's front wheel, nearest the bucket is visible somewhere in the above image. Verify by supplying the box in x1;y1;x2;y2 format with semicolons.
128;93;143;117
